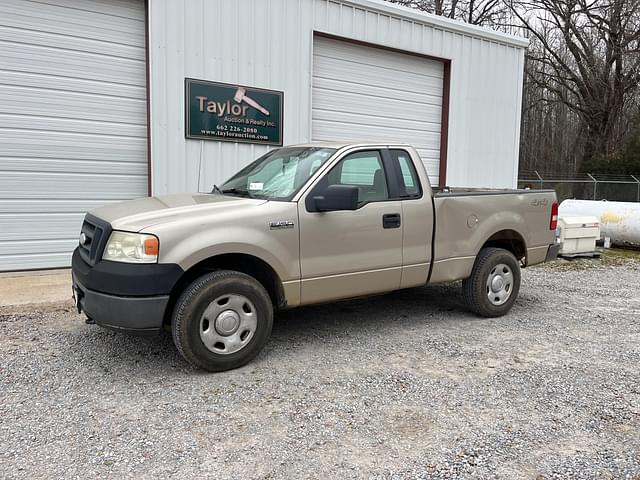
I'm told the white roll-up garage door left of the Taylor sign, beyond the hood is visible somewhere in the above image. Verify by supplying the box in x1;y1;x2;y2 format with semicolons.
0;0;148;271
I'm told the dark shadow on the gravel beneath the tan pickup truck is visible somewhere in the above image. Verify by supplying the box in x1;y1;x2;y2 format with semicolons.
60;284;475;377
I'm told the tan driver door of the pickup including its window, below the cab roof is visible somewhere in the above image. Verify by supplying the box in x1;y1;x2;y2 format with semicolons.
298;149;402;303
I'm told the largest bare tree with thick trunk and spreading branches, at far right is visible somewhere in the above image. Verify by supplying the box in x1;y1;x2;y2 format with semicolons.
509;0;640;167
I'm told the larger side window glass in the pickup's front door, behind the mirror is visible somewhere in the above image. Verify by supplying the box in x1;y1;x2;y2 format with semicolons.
327;150;389;204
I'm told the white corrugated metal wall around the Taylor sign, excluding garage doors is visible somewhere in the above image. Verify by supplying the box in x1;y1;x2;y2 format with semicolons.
149;0;526;194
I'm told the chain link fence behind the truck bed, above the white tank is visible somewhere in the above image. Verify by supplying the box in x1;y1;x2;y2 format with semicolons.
518;170;640;202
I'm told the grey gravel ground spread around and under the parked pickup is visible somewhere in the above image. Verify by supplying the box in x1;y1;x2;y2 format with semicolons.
0;255;640;479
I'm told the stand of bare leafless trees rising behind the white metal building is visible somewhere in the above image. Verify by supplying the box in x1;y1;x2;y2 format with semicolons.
388;0;640;173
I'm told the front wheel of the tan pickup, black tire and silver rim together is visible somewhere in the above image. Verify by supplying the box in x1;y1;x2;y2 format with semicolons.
171;270;273;372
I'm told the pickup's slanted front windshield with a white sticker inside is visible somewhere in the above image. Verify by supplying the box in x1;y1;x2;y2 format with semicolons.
219;147;336;200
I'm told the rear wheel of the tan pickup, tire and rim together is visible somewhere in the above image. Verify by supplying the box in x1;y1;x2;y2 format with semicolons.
462;248;520;317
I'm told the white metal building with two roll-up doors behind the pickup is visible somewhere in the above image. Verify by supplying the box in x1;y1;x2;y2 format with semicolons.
0;0;527;270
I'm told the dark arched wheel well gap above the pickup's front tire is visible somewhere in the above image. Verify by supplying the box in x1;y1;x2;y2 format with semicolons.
163;253;285;325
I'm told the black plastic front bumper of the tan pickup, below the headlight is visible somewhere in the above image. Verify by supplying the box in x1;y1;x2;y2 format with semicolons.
71;249;183;335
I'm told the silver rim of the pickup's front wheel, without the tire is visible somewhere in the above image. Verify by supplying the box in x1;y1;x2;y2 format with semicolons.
200;294;258;355
